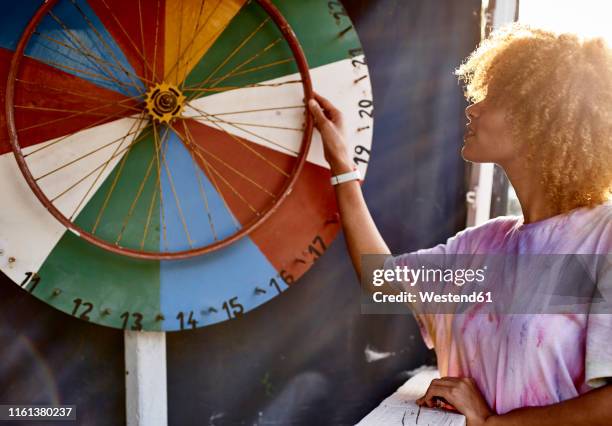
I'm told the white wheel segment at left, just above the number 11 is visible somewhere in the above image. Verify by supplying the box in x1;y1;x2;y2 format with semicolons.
0;117;142;283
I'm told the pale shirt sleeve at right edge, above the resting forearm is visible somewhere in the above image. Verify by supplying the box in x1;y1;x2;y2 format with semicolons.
585;255;612;388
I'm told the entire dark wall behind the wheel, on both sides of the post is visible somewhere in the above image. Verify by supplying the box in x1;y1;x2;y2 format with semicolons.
0;0;480;426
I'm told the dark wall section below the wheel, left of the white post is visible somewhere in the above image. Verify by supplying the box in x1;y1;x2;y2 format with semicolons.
0;280;125;426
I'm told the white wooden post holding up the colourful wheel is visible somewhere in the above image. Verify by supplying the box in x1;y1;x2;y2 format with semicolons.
124;331;168;426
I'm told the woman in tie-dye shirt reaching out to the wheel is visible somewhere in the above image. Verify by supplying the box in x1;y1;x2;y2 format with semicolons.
309;24;612;426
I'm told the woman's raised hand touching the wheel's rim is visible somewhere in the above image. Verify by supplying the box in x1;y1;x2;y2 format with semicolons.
308;93;353;175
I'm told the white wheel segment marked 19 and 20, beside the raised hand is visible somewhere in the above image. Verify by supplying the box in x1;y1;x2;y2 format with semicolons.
183;56;373;174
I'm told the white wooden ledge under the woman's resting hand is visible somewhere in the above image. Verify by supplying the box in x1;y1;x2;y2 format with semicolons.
357;367;466;426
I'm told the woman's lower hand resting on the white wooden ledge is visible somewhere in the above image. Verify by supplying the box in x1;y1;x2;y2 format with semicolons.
416;377;494;426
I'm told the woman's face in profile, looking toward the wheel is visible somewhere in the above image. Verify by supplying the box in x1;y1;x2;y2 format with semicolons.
461;99;517;166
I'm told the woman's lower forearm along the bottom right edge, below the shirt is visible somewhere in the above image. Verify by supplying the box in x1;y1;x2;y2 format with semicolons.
485;385;612;426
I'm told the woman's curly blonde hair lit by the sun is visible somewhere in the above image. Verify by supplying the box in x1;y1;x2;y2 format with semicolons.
455;24;612;212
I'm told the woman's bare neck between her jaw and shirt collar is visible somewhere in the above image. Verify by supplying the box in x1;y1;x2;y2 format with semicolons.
503;164;560;224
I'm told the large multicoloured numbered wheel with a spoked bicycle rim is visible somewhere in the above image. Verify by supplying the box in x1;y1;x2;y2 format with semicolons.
0;0;373;330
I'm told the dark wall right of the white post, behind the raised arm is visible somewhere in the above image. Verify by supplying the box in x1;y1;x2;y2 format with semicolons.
167;0;480;426
